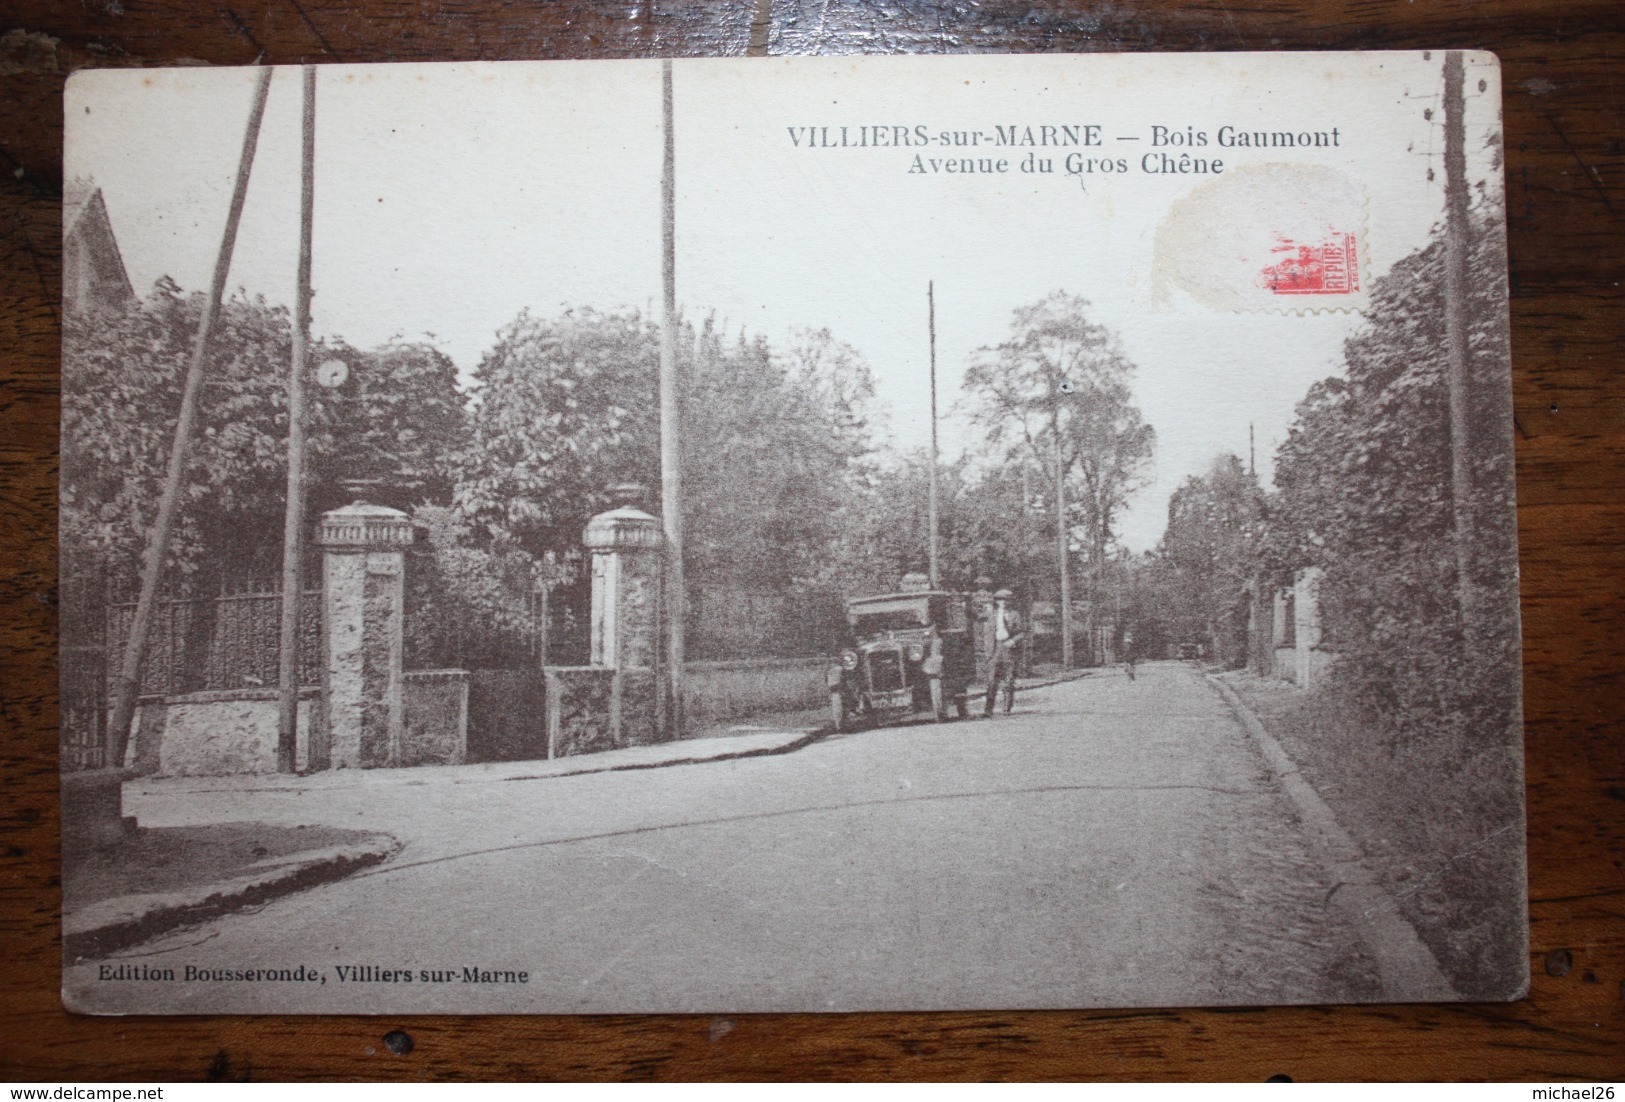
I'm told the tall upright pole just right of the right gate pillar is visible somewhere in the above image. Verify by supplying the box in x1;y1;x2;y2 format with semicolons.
660;62;684;738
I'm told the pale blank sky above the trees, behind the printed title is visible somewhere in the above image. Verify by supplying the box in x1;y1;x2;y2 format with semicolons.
65;54;1500;551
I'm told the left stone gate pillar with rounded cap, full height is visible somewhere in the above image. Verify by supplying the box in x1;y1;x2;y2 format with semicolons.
310;501;413;769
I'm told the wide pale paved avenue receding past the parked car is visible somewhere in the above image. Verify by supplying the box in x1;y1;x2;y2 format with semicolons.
76;663;1381;1013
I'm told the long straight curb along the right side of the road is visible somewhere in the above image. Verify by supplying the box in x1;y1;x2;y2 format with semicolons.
1204;673;1461;1001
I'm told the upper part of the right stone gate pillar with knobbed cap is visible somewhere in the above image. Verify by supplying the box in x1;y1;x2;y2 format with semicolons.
582;486;666;670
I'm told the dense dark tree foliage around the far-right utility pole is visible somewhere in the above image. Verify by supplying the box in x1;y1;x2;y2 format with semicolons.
1271;200;1518;743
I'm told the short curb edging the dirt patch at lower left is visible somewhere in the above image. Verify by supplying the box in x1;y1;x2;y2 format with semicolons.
62;834;401;961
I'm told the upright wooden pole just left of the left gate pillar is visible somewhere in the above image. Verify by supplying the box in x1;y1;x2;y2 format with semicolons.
276;65;315;774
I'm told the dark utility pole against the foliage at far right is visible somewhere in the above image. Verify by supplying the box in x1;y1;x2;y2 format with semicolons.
1445;50;1477;636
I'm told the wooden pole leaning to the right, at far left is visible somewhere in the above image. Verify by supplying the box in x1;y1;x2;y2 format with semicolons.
109;68;271;766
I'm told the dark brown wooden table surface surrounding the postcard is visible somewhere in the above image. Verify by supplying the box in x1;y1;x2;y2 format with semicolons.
0;0;1625;1082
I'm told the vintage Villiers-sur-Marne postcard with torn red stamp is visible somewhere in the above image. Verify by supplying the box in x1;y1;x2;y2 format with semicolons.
62;52;1528;1014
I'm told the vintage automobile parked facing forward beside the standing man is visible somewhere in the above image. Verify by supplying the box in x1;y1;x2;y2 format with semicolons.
827;590;977;731
